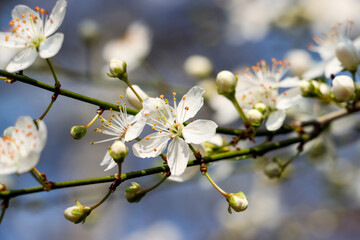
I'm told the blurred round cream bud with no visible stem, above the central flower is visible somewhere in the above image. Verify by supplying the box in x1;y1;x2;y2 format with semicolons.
184;55;213;79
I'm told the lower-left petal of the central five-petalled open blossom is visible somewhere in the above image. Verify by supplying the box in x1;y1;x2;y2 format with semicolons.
132;133;170;158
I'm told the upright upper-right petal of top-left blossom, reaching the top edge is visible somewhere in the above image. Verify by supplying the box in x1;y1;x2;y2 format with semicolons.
44;0;67;37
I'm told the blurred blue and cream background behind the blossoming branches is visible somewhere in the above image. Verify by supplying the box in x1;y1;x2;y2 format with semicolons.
0;0;360;240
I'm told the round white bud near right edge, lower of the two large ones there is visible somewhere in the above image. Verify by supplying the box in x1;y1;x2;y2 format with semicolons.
331;75;355;102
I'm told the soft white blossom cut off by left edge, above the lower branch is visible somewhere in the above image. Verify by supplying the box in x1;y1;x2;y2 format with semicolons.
0;116;47;174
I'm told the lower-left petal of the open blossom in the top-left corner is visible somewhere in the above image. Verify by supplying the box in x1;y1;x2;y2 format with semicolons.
6;48;37;72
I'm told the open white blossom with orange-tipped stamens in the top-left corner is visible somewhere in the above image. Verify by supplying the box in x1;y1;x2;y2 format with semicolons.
0;0;67;72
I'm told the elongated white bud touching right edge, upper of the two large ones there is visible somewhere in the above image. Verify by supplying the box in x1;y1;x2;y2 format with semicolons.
335;39;360;71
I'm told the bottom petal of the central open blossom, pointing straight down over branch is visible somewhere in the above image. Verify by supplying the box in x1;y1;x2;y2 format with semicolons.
167;137;190;176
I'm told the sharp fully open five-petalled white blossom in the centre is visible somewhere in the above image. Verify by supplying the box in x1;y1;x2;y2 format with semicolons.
133;86;217;176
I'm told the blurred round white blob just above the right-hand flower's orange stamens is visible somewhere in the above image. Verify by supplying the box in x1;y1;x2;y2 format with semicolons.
285;49;313;77
